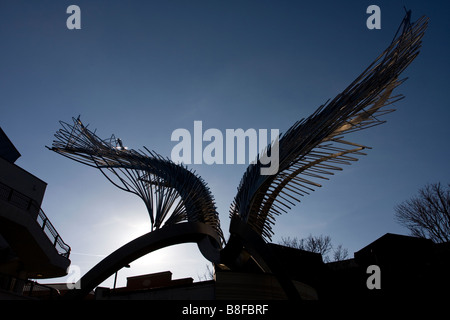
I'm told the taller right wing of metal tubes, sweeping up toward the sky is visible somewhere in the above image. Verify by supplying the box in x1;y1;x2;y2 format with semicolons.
230;17;428;241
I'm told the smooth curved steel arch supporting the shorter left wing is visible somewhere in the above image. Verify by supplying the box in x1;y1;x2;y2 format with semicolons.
64;222;220;299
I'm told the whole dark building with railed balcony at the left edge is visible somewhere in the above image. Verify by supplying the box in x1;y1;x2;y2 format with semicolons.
0;128;70;298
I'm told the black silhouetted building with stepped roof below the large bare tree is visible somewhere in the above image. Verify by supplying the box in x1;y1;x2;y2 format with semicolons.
325;233;450;300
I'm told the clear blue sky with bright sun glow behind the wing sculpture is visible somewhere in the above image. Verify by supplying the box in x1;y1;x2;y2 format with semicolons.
0;0;450;286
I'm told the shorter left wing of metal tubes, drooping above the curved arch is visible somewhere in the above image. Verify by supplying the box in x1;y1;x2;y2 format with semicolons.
51;117;223;238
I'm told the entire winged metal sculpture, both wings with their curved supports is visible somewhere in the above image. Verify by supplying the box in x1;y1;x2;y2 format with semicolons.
51;11;428;298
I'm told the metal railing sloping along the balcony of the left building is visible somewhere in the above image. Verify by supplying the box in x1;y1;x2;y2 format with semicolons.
0;182;70;259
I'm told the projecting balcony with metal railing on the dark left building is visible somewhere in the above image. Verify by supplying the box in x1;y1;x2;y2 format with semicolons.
0;182;70;279
